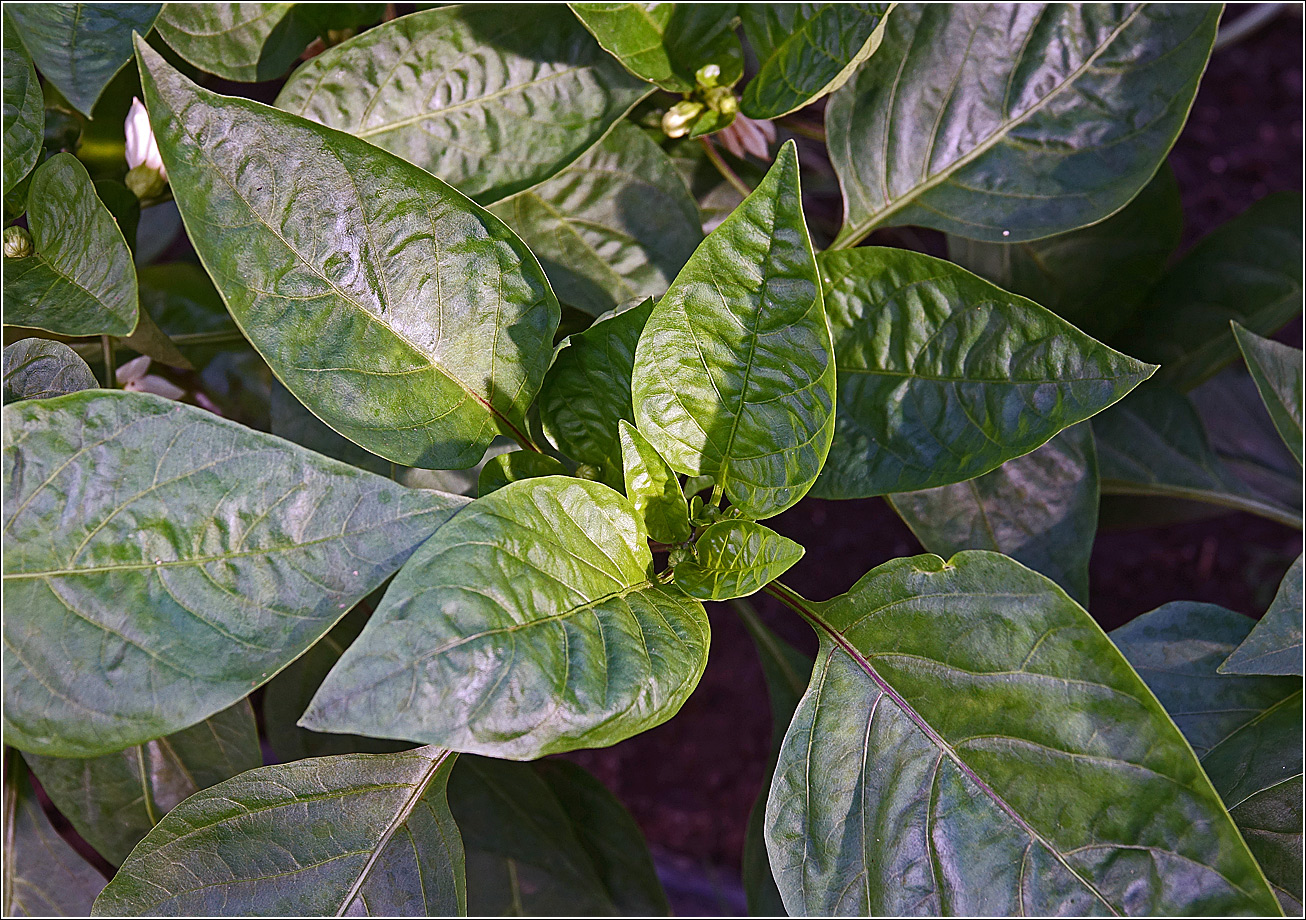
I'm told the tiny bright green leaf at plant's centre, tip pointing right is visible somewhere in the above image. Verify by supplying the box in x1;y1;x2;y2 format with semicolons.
675;520;804;601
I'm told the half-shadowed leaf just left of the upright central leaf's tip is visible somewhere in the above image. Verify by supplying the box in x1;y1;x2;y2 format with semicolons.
490;122;703;316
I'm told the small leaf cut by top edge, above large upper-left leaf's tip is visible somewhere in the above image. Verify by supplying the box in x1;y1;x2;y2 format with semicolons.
152;3;316;82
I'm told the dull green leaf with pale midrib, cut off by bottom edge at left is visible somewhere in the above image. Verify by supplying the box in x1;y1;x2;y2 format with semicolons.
94;748;466;916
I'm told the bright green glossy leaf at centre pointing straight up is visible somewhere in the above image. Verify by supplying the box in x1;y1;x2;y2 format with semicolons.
632;141;835;519
